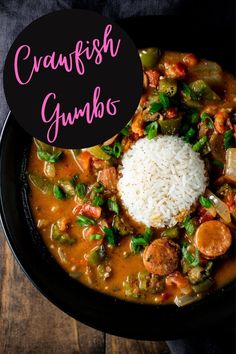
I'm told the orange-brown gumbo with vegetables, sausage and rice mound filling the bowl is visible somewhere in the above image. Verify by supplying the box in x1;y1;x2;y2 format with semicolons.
28;48;236;306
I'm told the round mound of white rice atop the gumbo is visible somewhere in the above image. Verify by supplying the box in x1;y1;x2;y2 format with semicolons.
118;136;207;228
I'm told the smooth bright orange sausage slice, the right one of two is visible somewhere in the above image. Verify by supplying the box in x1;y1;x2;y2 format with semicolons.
194;220;232;259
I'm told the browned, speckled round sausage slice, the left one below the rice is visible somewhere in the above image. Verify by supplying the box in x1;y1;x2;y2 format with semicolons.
143;237;179;275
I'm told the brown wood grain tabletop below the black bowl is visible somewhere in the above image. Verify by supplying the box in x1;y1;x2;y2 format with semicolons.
0;229;170;354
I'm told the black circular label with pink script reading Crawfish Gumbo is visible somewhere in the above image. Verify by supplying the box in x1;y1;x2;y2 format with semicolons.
4;10;142;148
